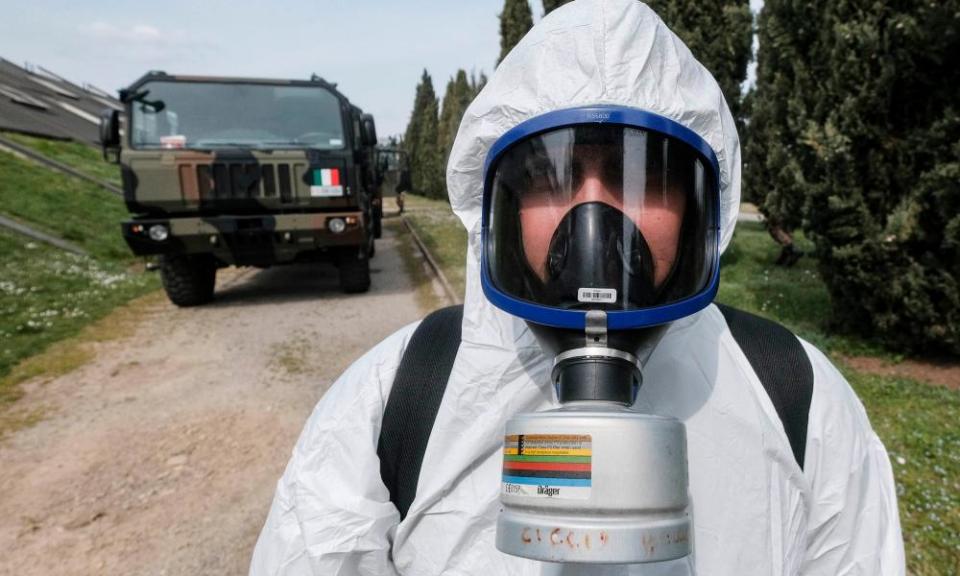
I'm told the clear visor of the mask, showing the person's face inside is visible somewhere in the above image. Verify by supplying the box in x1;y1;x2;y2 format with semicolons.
486;124;717;310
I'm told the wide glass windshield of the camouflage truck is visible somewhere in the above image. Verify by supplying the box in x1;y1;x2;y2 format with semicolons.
130;81;344;150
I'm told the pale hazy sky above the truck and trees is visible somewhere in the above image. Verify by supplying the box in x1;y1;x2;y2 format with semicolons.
0;0;762;136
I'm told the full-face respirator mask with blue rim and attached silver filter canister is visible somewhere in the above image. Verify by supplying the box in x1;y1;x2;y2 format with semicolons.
481;106;719;563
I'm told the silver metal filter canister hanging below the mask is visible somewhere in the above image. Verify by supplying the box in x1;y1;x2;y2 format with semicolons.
497;406;690;564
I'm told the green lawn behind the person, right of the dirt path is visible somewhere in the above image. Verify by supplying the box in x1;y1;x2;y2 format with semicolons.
408;196;960;576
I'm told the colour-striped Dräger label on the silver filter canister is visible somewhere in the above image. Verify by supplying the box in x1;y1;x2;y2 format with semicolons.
502;434;593;499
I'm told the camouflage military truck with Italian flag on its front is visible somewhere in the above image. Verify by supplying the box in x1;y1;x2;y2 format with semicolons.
100;72;382;306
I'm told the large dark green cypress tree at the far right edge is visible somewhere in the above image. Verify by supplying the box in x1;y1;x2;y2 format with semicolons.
800;0;960;354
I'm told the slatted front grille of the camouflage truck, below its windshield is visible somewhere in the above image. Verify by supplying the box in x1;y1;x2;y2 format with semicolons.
180;162;294;202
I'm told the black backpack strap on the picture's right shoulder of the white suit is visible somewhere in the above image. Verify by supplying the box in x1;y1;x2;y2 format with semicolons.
717;304;813;469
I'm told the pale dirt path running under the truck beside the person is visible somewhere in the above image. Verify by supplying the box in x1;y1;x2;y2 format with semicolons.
0;225;423;576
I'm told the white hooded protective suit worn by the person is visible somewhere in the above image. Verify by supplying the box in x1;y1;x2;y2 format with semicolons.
250;0;905;576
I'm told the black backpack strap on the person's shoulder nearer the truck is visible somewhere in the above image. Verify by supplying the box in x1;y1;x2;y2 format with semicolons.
377;305;463;520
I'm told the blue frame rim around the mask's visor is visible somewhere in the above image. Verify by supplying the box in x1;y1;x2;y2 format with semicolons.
480;106;720;330
